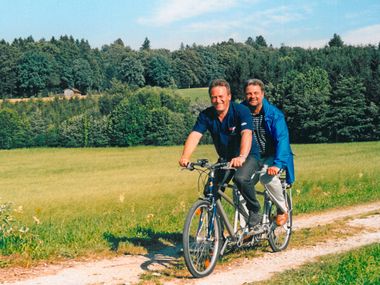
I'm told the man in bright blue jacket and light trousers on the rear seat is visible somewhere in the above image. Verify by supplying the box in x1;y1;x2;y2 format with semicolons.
242;79;294;226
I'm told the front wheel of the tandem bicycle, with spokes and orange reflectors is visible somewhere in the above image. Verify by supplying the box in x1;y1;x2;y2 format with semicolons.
183;200;221;278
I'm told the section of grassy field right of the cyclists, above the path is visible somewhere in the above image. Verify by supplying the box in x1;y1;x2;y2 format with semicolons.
293;142;380;213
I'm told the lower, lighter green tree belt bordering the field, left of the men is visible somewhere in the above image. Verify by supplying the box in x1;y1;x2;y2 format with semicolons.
0;82;202;149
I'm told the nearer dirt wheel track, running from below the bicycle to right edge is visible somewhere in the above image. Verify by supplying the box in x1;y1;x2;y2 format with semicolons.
167;215;380;285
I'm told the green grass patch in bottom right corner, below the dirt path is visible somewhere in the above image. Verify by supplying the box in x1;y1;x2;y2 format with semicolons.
253;244;380;285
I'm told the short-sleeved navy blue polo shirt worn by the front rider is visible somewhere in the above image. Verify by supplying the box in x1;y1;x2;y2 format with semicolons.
193;102;260;161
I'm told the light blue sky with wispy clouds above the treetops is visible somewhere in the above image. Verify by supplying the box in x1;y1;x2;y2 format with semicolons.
0;0;380;50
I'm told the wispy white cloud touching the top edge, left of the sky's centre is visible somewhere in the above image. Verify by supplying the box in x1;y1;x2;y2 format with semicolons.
138;0;237;26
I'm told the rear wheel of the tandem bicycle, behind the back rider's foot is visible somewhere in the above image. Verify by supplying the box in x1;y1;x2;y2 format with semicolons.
268;192;293;252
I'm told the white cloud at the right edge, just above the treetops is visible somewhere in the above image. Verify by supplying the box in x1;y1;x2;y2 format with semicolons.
341;24;380;45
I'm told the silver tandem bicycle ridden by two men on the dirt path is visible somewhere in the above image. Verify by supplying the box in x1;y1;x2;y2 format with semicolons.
183;159;292;278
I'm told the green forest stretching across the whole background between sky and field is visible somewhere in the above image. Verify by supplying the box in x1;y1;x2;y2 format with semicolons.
0;34;380;144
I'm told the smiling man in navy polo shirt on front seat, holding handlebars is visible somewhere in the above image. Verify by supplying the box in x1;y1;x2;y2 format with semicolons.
179;79;260;227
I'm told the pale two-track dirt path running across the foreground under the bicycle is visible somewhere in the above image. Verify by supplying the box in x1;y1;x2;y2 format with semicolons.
0;201;380;285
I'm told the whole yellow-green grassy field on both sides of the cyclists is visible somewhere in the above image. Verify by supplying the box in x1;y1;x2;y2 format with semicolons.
0;142;380;266
